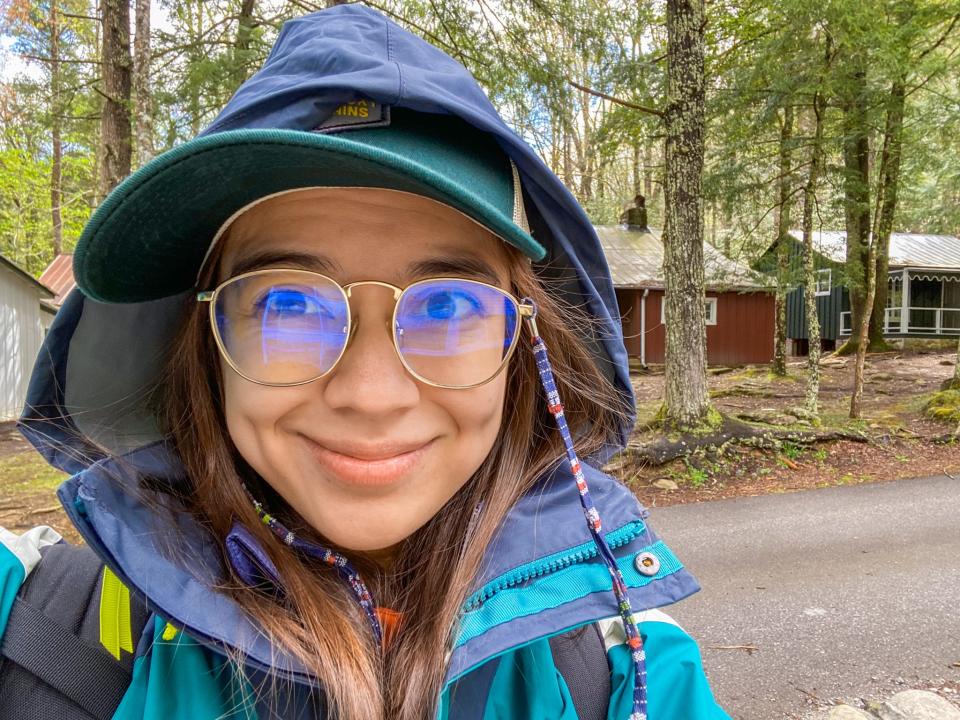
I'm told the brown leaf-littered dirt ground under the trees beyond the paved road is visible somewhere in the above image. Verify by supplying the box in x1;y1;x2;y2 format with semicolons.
0;350;960;542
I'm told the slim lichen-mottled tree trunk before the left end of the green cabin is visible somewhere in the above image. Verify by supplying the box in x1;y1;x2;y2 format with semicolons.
803;89;829;416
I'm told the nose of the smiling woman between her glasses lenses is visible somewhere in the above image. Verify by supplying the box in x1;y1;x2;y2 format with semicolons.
323;293;420;417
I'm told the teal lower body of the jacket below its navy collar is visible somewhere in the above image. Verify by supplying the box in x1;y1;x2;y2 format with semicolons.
0;516;728;720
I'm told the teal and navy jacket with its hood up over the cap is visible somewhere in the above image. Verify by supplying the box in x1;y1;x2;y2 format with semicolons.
0;4;727;720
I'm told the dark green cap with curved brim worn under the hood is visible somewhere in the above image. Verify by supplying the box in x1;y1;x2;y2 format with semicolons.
73;105;546;303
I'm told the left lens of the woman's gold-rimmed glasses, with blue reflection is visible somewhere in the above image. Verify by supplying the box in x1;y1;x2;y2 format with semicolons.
214;270;348;384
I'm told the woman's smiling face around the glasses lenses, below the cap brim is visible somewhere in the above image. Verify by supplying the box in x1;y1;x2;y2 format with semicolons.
218;188;509;556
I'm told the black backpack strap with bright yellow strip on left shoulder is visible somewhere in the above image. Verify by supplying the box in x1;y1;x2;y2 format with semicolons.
0;543;149;720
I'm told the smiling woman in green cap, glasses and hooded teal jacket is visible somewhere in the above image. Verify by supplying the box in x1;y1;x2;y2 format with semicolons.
0;5;726;720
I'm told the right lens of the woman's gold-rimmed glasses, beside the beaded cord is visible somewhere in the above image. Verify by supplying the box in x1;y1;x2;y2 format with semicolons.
394;279;518;387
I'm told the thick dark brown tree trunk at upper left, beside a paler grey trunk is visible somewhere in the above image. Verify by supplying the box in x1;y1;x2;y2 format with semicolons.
99;0;132;198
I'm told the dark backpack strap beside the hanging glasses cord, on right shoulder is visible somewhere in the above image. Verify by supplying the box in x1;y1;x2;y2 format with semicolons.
550;623;610;720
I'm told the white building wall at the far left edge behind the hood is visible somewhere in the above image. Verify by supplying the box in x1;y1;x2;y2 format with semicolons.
0;255;56;422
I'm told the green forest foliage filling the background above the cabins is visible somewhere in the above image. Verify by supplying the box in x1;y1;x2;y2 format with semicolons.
0;0;960;292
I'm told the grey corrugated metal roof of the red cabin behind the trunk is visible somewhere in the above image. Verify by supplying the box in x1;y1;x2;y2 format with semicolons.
594;225;771;290
